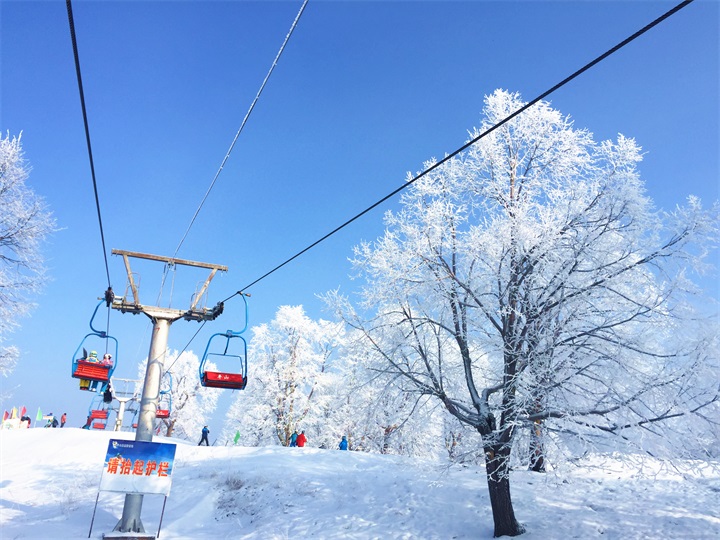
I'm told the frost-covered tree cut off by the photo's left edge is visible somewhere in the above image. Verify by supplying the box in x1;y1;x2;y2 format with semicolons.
0;133;55;376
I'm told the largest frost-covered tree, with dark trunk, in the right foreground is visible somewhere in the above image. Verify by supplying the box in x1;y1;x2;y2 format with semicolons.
335;91;719;536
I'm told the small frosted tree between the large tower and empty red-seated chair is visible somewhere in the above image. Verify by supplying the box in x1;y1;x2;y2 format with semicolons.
138;350;220;440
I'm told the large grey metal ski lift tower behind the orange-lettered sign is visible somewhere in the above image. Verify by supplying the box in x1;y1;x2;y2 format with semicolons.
103;249;227;539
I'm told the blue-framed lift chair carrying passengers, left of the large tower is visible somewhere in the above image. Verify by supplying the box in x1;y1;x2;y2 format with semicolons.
72;299;118;392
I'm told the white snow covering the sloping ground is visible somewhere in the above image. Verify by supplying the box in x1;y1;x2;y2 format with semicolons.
0;428;720;540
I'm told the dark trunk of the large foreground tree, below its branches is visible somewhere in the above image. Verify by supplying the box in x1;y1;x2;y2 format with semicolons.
485;445;525;538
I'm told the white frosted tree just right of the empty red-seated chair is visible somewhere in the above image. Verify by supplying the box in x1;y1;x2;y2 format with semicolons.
223;306;344;446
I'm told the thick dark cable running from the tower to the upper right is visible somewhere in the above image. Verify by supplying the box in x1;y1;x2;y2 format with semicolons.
228;0;694;302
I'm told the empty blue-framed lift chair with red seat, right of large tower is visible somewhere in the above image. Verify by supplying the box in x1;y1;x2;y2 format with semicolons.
199;293;248;390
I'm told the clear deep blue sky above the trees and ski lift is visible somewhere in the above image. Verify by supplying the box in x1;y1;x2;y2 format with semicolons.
0;0;720;427
